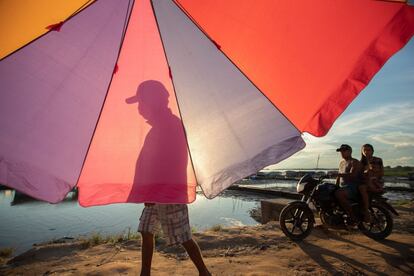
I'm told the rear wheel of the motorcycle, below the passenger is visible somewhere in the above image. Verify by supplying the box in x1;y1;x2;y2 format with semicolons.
358;204;394;240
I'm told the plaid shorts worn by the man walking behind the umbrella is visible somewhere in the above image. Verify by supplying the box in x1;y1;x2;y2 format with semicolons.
138;204;192;245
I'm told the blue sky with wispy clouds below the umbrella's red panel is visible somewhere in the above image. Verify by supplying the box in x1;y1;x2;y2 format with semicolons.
268;35;414;169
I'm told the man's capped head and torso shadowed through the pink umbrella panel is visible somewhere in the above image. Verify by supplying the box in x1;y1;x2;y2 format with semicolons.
126;80;188;203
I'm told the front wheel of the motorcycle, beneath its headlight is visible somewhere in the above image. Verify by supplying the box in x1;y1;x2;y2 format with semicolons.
279;203;315;241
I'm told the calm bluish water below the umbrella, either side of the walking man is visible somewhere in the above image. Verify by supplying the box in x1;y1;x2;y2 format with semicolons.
0;190;264;254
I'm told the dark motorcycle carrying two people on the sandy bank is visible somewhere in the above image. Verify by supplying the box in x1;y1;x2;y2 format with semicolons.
279;174;398;241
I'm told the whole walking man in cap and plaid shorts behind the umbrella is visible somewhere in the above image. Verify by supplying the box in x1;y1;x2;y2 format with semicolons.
126;80;211;275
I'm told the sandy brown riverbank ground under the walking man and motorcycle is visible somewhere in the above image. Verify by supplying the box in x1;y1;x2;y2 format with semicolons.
0;201;414;275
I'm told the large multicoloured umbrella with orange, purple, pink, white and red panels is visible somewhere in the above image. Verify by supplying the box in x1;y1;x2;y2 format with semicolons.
0;0;414;206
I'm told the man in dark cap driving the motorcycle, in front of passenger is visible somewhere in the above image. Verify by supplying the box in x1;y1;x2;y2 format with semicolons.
335;144;369;221
